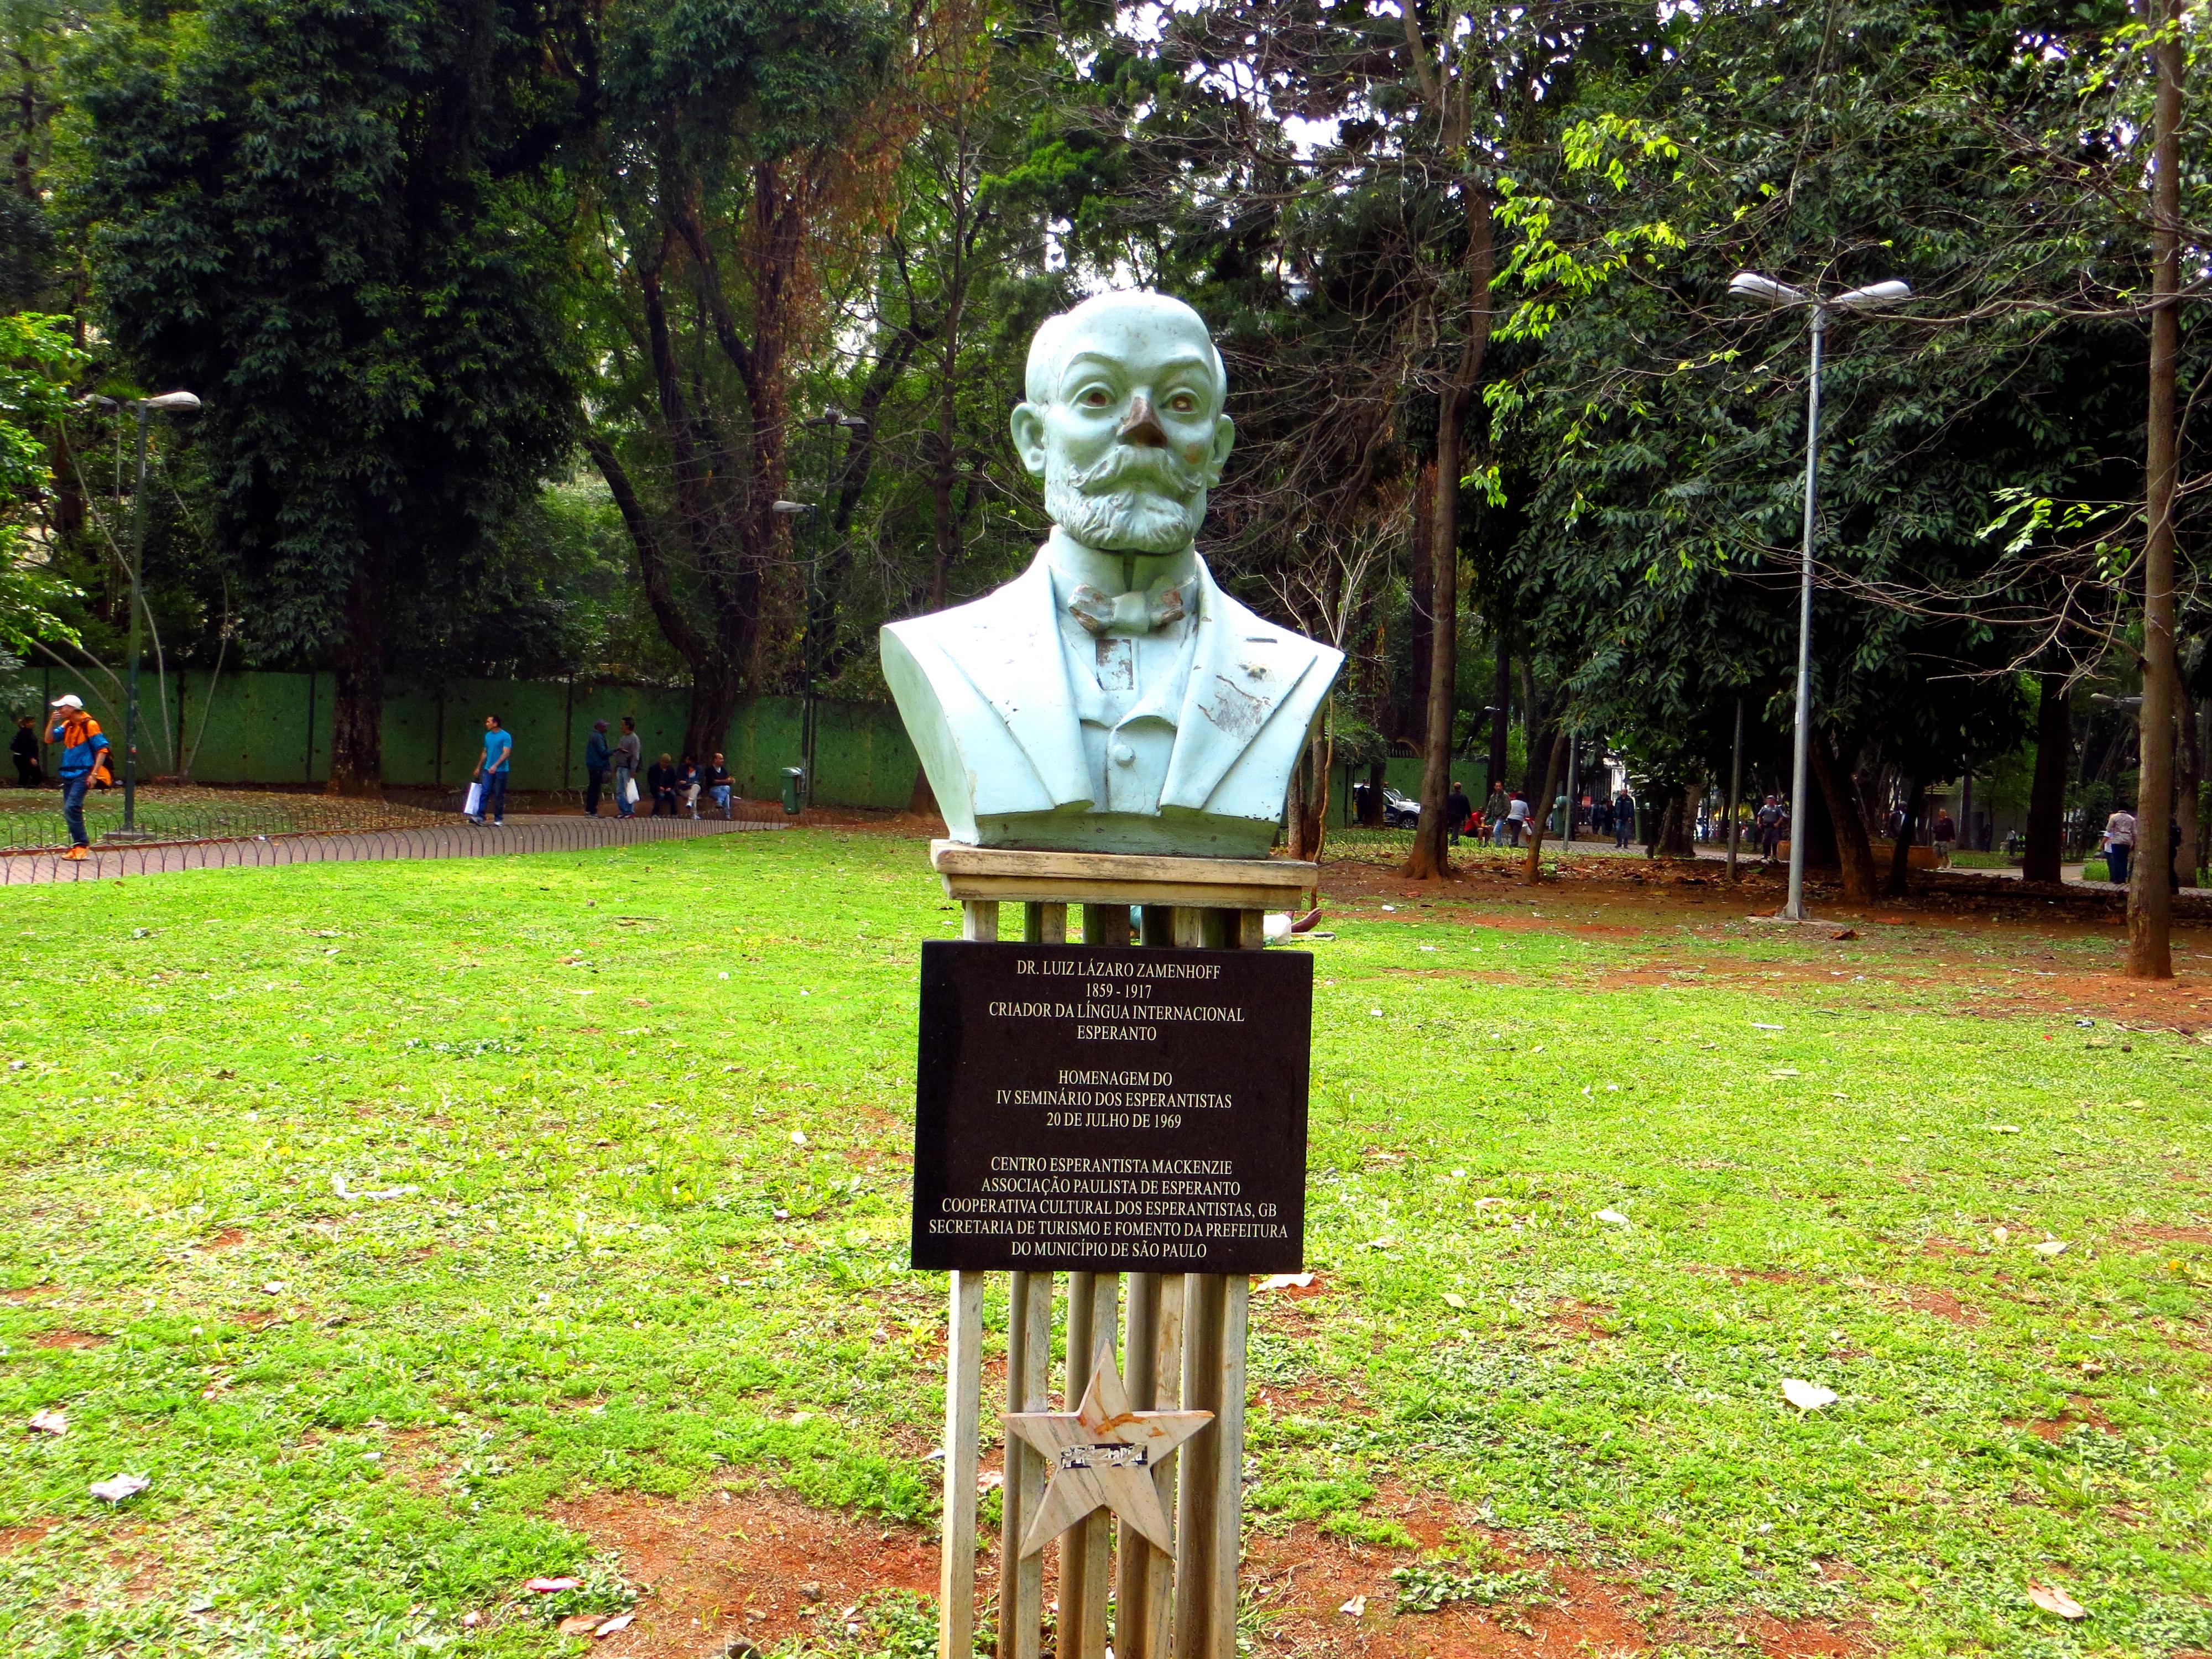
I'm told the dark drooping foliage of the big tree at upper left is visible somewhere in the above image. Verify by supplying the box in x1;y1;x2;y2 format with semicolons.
73;0;580;657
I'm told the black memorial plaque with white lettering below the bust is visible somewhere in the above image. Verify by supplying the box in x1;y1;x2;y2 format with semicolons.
914;940;1314;1274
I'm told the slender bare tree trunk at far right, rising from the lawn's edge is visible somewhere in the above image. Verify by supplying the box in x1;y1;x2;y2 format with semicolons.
2128;0;2181;980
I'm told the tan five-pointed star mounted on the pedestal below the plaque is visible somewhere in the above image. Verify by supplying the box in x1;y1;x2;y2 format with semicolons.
1006;1343;1214;1555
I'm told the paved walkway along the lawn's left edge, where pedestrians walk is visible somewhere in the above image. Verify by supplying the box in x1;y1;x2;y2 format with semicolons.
0;816;785;887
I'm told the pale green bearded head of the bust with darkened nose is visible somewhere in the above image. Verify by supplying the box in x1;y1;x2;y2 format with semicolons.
1013;290;1237;555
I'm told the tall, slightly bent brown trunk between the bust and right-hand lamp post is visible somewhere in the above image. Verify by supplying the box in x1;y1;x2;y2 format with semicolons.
1405;181;1495;880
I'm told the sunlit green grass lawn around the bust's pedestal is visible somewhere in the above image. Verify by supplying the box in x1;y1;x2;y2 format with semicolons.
0;832;2212;1657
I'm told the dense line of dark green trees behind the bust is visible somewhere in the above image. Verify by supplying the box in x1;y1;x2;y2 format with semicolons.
0;0;2212;960
